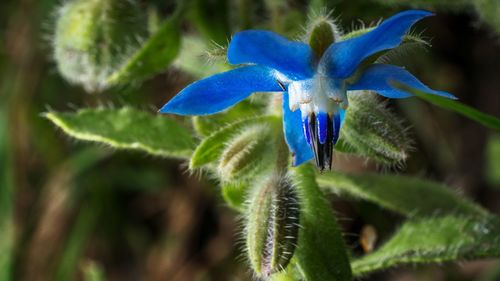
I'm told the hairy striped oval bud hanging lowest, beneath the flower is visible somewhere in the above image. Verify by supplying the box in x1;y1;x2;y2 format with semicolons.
246;175;300;277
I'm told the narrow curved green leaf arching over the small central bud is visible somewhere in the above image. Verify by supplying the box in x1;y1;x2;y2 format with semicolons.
189;116;276;169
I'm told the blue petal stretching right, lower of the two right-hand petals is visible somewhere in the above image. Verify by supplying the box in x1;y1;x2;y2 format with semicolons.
347;64;456;99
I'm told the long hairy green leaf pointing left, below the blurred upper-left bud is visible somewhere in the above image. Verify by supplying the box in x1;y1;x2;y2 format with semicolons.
45;107;195;158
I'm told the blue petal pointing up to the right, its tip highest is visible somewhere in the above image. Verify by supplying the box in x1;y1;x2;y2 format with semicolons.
320;10;432;79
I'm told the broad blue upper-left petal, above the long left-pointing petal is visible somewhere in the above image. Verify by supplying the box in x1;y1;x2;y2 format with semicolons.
227;30;314;80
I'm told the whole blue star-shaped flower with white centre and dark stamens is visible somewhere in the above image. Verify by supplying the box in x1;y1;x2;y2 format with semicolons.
160;10;455;170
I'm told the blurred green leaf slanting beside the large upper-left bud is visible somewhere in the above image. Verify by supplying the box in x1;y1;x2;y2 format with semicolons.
107;18;180;84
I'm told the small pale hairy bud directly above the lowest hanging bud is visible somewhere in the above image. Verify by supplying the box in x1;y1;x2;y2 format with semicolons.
218;124;276;181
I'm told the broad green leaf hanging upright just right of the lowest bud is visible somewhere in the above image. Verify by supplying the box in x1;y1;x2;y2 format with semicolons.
291;165;352;281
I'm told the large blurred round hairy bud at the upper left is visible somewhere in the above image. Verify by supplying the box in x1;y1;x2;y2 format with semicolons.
53;0;147;92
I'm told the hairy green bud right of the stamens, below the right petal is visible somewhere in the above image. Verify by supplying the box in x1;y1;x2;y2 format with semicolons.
341;92;411;165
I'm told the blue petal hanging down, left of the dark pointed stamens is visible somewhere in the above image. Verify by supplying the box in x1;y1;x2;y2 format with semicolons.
283;92;313;166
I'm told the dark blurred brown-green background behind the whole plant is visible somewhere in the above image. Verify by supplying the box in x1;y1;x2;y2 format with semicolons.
0;0;500;281
